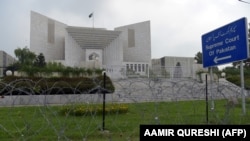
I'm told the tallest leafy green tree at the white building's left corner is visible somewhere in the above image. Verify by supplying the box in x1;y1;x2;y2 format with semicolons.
14;46;36;65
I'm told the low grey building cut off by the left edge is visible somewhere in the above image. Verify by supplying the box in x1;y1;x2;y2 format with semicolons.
0;50;16;77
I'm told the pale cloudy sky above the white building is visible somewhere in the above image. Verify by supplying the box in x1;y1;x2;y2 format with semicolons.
0;0;250;68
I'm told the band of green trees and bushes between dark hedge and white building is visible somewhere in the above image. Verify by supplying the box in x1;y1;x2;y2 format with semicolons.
9;47;103;77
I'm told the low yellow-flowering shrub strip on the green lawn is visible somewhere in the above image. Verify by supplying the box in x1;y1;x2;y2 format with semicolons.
59;103;128;116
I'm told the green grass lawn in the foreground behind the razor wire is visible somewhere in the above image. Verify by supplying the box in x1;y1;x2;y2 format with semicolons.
0;99;250;141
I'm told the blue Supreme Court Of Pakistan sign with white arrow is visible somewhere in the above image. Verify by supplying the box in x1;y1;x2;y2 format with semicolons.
202;17;249;68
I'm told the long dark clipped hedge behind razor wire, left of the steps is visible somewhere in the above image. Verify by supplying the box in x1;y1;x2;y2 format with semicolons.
0;76;115;95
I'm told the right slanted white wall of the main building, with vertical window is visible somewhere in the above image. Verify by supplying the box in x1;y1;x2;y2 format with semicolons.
115;21;151;64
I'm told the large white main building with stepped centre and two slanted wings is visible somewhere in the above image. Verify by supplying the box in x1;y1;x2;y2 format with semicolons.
30;11;151;78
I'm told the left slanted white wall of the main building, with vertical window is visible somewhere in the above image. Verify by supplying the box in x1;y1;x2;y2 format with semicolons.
30;11;67;61
